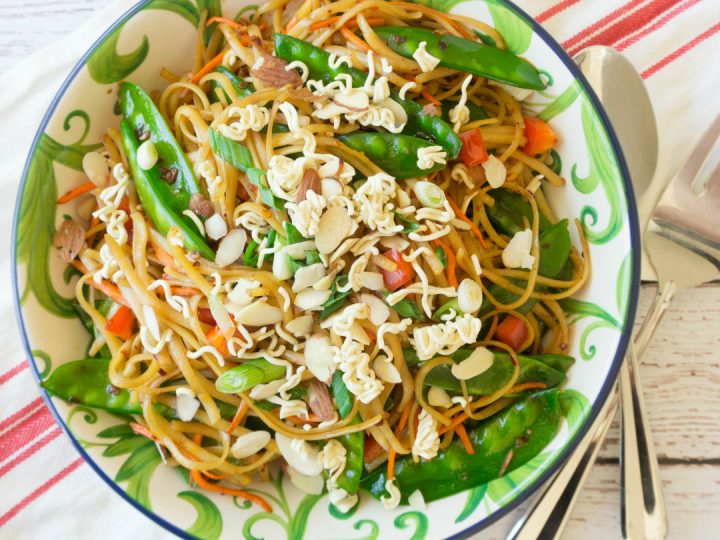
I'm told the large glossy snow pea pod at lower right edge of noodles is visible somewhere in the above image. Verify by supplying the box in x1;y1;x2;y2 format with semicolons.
362;389;561;503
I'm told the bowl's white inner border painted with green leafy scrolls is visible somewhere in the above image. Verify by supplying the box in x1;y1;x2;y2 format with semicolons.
15;0;638;540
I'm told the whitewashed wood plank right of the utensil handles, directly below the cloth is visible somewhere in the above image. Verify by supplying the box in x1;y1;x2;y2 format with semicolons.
601;284;720;461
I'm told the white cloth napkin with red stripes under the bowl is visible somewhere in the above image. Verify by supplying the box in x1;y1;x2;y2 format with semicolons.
0;0;720;539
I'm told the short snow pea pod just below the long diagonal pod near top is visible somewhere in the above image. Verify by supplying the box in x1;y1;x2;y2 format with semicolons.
336;132;445;180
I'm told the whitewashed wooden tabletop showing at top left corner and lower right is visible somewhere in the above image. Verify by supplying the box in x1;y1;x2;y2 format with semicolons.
0;0;720;540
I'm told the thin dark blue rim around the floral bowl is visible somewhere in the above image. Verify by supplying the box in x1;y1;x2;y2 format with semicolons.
10;0;641;540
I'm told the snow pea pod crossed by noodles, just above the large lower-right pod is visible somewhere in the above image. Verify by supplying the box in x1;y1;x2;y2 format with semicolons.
403;347;575;396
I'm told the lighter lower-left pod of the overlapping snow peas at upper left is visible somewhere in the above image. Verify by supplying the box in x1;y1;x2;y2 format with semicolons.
120;120;215;261
